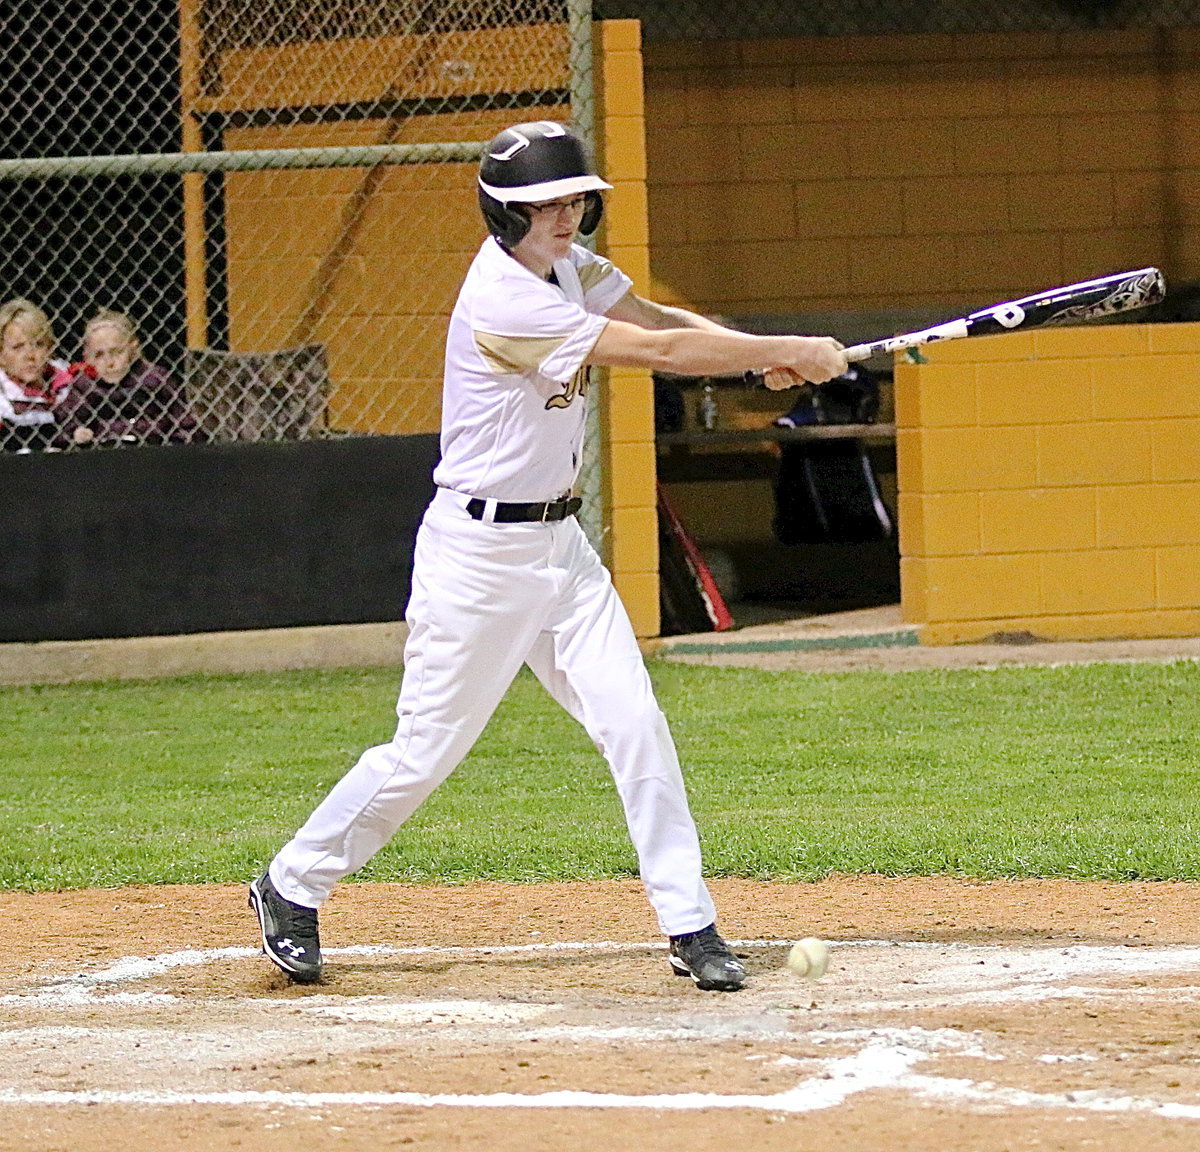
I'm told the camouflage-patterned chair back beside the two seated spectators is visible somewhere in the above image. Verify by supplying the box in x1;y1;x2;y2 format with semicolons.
184;344;332;440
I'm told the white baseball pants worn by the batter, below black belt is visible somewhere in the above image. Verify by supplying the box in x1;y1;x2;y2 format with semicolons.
270;488;715;935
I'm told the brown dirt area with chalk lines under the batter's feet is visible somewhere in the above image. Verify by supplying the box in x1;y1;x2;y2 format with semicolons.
7;877;1200;1152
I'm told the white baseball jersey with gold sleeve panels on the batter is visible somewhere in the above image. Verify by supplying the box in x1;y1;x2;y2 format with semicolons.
433;236;632;502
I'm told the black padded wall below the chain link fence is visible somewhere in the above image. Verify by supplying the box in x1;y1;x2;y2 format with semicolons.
0;436;438;641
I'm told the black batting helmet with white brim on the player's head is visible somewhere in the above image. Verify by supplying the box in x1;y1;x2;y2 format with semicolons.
479;120;612;248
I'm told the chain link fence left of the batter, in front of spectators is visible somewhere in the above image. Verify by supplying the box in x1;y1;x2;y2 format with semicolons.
0;0;592;450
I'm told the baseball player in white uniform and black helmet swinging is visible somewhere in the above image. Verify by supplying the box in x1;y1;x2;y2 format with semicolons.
250;121;846;991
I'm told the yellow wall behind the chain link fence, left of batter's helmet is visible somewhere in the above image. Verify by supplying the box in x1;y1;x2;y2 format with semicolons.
199;24;570;434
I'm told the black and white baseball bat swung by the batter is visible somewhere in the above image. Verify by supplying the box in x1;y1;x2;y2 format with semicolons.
748;268;1166;383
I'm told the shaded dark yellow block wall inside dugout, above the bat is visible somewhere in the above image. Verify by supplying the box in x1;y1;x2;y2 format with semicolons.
646;29;1200;314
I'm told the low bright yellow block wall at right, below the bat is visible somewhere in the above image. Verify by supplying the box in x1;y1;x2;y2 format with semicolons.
896;324;1200;644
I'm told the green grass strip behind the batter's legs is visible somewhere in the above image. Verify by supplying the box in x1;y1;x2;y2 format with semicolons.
0;662;1200;889
